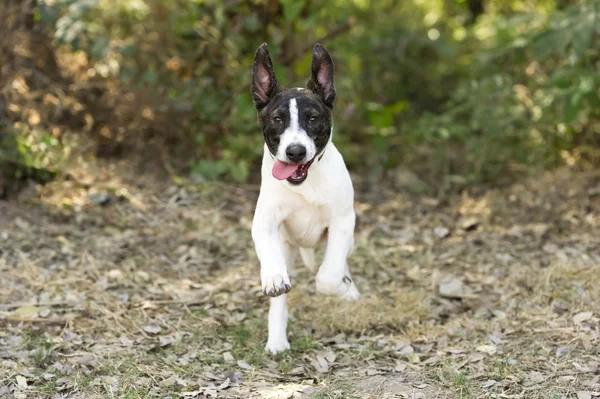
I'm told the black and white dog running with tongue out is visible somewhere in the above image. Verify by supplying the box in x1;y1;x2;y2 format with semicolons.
252;43;360;353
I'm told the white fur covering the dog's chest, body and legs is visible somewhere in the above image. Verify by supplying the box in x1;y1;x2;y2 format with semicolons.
252;133;360;353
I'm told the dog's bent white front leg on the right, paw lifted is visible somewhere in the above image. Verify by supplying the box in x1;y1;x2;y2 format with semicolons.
316;210;360;300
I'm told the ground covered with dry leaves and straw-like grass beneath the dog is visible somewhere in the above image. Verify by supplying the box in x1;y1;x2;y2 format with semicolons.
0;164;600;399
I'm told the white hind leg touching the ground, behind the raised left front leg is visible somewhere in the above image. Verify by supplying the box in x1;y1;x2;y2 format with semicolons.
265;237;298;354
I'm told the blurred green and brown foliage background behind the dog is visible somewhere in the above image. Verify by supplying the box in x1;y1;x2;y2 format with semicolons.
0;0;600;195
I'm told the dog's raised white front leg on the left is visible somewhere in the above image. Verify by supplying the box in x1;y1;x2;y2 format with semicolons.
252;206;292;297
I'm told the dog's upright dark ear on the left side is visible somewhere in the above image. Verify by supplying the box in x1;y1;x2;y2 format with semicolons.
252;43;280;110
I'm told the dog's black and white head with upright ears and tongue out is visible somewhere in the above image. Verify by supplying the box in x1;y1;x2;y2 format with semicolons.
252;43;335;184
